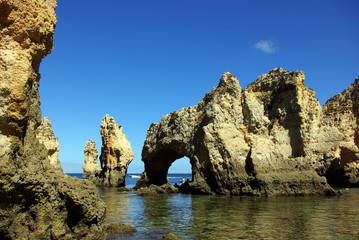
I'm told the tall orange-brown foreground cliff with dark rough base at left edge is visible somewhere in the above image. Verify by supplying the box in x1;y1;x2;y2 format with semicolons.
0;0;106;239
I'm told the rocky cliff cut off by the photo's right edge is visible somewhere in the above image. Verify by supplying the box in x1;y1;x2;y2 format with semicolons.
323;77;359;187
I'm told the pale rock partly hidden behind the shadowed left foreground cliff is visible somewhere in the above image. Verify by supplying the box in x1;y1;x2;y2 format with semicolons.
36;118;62;171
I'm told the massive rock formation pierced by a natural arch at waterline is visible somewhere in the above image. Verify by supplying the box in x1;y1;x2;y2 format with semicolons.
136;68;341;195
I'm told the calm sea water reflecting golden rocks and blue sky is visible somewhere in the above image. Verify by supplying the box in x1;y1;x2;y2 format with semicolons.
69;174;359;239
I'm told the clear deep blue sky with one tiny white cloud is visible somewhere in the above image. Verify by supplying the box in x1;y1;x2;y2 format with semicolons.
40;0;359;173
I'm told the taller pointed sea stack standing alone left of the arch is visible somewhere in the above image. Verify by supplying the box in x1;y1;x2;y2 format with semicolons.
98;114;134;187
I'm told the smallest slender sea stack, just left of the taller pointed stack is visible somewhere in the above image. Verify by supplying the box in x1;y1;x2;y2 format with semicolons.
82;139;101;183
